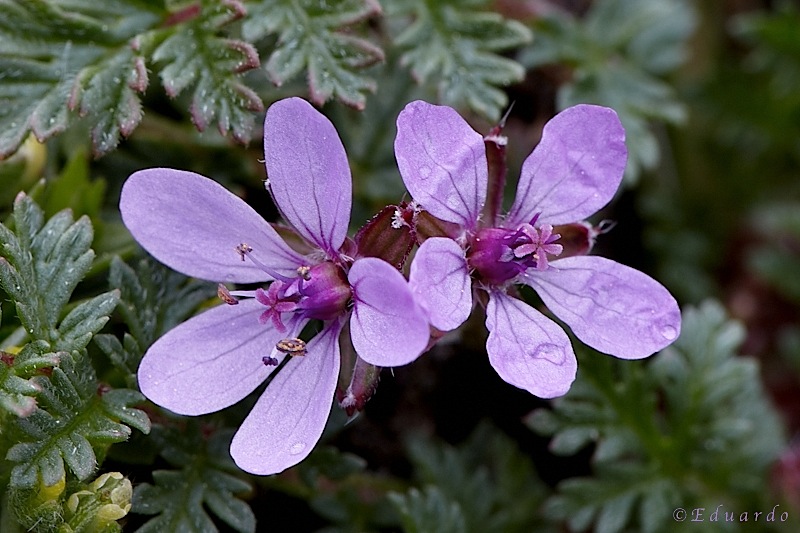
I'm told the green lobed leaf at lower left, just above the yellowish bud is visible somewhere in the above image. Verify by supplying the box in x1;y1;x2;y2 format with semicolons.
6;354;150;489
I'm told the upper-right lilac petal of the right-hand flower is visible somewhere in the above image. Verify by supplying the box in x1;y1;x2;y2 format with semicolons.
504;105;628;227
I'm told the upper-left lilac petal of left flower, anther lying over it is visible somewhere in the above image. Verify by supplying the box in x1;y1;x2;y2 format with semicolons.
119;168;305;283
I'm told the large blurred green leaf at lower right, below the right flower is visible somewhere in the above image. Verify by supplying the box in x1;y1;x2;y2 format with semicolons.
528;302;783;533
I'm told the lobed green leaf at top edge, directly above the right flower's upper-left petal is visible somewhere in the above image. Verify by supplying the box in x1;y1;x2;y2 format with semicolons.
390;0;531;120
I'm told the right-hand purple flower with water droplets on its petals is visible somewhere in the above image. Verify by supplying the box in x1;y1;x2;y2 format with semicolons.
395;101;680;398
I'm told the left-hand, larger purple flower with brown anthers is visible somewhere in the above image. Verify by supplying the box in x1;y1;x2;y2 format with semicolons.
120;98;429;474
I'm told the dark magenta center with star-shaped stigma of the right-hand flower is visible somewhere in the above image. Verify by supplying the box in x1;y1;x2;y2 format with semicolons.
467;217;563;285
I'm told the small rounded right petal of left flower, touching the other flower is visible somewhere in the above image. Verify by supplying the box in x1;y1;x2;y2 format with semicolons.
348;257;430;366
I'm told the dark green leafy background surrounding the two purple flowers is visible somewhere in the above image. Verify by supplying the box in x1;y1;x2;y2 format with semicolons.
0;0;800;533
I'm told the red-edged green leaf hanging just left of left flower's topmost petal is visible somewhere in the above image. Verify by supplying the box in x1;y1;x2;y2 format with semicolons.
153;0;264;143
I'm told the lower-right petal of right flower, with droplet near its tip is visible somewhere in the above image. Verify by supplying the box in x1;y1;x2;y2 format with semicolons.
525;256;681;359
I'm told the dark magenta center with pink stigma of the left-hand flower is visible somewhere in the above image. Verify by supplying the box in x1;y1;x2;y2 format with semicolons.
256;261;353;332
